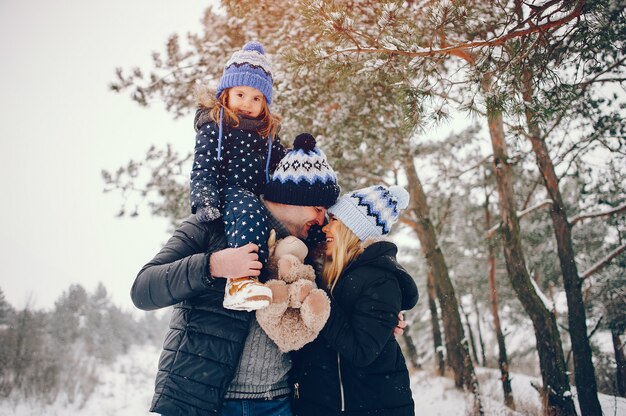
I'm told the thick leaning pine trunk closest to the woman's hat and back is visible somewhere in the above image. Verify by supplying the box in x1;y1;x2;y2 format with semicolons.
404;156;483;414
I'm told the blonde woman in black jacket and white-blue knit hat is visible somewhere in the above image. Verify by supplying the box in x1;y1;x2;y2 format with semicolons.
294;186;418;416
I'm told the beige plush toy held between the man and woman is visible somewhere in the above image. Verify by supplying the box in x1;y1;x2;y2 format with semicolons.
256;230;330;352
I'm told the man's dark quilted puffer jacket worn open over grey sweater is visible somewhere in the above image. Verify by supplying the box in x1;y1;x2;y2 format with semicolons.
131;216;253;416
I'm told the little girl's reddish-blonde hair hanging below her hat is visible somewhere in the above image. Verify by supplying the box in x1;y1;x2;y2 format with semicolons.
196;87;281;137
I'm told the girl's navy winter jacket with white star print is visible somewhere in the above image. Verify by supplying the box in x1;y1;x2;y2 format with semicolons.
190;109;285;213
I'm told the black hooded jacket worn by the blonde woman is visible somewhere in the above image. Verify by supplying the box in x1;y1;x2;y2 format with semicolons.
294;241;418;416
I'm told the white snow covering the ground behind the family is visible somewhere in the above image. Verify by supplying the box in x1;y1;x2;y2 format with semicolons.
0;346;626;416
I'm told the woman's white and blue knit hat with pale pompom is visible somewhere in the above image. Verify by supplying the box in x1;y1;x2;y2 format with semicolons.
328;185;409;241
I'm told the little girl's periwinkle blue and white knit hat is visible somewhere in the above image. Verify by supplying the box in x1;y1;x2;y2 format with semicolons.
215;41;274;106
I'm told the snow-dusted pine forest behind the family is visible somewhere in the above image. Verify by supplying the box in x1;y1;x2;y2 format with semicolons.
0;0;626;416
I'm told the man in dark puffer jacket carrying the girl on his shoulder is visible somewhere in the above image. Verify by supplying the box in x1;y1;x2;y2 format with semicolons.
131;137;404;416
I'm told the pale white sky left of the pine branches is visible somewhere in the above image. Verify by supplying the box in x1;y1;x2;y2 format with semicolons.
0;0;208;309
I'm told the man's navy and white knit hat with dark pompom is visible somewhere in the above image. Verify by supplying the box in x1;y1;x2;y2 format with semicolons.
265;133;339;207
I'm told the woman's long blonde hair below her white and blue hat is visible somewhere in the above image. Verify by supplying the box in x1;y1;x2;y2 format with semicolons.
322;220;363;292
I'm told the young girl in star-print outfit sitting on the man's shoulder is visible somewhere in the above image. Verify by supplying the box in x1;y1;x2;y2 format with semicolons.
190;42;285;311
